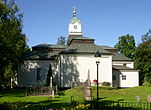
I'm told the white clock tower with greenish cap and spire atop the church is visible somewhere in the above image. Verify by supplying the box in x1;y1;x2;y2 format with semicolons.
68;7;82;36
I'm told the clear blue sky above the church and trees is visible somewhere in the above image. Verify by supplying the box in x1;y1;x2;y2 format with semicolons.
15;0;151;47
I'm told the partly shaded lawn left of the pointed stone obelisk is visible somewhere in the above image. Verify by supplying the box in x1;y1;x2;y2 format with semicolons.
0;87;83;103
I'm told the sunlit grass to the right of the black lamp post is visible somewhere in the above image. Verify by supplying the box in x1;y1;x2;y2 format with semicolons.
96;86;151;102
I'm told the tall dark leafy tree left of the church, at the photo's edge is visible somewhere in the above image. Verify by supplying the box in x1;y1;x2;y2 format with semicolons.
0;0;29;87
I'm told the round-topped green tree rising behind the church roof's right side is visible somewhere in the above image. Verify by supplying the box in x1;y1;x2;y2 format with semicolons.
115;34;136;59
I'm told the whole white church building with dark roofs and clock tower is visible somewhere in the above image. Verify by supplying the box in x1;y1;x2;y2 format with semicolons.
17;9;139;87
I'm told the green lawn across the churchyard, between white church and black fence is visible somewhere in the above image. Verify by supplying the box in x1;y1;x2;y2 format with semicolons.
0;86;151;103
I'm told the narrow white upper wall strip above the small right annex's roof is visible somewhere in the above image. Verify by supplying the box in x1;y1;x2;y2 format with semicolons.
113;61;134;68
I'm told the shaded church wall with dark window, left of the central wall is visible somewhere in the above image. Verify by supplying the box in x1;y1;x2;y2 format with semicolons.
18;60;55;87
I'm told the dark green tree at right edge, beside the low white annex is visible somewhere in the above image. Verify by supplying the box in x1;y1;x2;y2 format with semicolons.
135;39;151;83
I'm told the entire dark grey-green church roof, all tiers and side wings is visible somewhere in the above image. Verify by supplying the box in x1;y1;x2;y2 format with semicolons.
24;41;132;61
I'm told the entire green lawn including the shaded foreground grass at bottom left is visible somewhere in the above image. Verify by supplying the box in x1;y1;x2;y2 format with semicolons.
0;86;151;110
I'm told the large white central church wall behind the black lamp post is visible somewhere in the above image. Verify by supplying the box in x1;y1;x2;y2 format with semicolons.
61;55;112;87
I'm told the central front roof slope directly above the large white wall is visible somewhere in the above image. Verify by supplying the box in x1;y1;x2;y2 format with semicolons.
61;43;111;54
